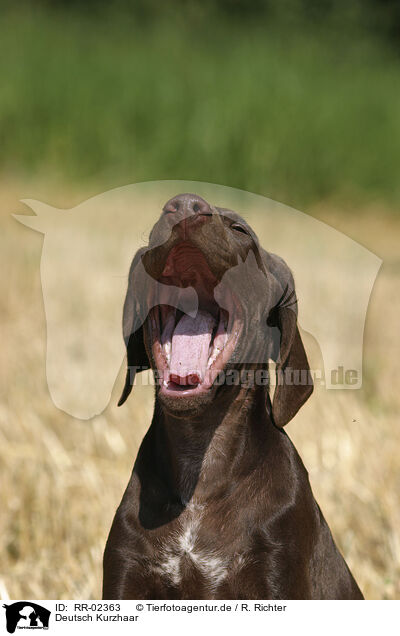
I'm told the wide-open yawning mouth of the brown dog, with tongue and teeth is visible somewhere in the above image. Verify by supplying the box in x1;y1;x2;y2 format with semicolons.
149;241;243;397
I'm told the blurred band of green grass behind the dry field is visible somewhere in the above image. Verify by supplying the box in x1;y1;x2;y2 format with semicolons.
0;5;400;209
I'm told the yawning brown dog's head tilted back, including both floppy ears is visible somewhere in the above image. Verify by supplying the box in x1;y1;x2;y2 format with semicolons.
119;194;313;426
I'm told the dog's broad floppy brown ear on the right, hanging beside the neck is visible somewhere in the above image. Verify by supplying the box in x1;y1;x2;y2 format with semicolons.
268;254;314;427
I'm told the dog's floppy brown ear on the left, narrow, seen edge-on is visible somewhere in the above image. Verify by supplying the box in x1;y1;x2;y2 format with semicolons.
118;248;150;406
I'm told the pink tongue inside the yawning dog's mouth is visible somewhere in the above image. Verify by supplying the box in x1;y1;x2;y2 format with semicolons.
169;311;215;385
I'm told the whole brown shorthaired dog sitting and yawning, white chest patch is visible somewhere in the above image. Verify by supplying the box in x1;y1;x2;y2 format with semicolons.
103;194;362;599
